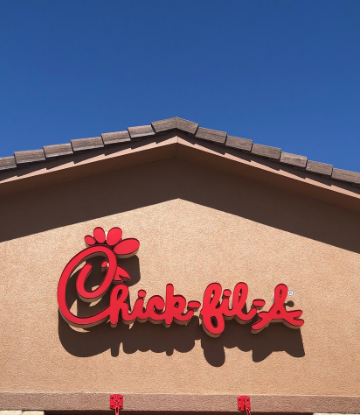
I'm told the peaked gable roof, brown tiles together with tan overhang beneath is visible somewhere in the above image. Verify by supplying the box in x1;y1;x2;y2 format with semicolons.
0;117;360;221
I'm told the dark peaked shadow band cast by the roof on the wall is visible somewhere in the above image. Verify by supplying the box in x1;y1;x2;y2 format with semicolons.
0;158;360;253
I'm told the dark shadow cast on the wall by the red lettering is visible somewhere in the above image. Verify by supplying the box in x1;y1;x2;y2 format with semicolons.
59;257;305;367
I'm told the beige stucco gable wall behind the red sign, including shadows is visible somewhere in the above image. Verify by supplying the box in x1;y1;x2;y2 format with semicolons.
0;158;360;396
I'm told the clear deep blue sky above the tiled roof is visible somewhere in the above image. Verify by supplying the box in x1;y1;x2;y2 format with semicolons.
0;0;360;171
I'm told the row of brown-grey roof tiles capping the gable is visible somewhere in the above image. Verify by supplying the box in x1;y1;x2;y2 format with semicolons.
0;117;360;185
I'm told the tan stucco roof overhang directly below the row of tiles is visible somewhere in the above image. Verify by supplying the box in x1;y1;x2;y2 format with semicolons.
0;130;360;211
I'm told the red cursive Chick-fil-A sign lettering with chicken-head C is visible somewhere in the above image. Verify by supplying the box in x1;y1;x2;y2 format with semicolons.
58;228;304;337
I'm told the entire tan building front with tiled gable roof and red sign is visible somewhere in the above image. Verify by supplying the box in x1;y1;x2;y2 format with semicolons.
0;118;360;414
